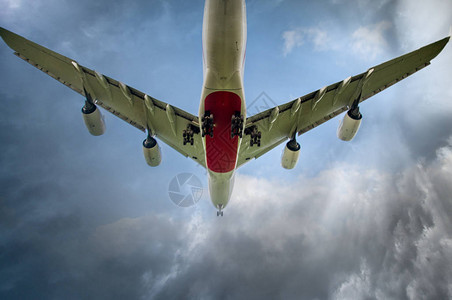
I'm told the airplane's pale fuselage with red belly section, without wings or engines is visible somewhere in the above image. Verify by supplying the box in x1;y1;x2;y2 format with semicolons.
199;0;246;210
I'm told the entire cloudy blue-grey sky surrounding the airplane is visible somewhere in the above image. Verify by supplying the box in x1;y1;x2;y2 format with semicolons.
0;0;452;299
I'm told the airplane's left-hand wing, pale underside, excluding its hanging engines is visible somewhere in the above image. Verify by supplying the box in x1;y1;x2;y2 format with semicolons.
0;27;206;167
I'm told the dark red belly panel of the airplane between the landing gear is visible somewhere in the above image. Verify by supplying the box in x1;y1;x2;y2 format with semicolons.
204;91;242;173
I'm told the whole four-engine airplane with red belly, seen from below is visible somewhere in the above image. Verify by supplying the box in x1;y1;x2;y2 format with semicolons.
0;0;450;216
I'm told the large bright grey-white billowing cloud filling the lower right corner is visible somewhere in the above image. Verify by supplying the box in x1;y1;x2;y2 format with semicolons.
160;141;452;299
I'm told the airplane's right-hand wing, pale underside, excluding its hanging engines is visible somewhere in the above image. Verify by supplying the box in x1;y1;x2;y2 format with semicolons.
237;37;450;167
